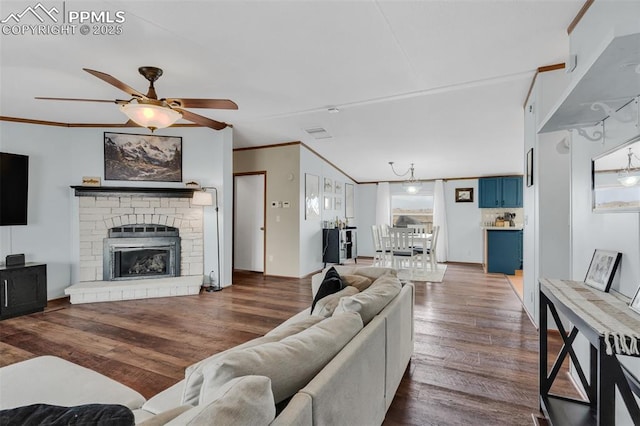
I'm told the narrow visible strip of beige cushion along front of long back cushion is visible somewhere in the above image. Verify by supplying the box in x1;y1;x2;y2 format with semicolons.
181;315;324;405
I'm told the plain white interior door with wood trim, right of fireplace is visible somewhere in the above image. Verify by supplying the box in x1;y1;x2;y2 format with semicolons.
233;173;265;272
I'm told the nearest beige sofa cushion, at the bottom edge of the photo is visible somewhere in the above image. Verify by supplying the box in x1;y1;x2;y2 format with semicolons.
167;376;276;426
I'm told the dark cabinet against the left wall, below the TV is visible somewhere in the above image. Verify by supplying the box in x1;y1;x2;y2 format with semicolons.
0;263;47;320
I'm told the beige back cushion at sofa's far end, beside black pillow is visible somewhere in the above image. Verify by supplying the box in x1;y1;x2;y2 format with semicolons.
333;274;402;325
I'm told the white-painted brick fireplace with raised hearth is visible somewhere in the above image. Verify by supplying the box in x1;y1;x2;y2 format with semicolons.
65;187;204;303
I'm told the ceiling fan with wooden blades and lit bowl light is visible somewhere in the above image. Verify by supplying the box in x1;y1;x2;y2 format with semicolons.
36;67;238;132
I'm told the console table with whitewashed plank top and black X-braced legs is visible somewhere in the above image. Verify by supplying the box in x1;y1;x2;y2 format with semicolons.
540;278;640;426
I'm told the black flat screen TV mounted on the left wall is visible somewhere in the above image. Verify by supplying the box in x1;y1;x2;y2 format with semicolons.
0;152;29;226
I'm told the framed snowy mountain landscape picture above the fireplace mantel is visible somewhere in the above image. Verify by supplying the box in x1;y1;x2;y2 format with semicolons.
104;132;182;182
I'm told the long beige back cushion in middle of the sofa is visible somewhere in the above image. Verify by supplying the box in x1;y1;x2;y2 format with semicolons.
200;312;362;403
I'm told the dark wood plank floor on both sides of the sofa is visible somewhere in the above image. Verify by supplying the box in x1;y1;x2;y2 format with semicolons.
0;265;575;425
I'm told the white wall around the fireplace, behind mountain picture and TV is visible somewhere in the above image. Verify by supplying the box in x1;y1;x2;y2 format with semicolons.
0;121;232;299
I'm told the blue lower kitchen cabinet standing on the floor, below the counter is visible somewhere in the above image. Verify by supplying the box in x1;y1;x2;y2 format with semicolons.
487;230;522;275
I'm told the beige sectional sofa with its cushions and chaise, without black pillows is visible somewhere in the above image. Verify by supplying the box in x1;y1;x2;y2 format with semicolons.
0;266;414;426
